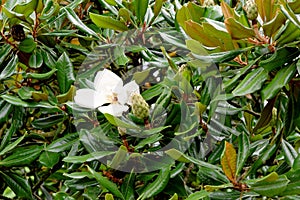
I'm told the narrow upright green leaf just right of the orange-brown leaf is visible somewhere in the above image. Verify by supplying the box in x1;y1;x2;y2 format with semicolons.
235;133;250;176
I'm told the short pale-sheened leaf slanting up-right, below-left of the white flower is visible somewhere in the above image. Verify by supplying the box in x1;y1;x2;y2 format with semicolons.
46;133;78;152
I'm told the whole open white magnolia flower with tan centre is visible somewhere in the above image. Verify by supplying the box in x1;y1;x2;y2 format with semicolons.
74;69;139;116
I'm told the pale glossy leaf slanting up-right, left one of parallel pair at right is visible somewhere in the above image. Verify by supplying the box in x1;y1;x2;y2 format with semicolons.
232;68;268;96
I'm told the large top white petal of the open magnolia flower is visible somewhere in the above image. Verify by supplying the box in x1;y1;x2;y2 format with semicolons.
94;69;123;92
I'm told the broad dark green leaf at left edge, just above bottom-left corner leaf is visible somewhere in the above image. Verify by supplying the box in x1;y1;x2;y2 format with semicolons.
0;145;43;167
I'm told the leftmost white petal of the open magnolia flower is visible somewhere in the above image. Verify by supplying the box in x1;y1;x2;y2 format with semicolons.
74;89;105;109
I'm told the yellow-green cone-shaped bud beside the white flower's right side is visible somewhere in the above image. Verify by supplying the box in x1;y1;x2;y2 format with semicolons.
131;93;149;119
